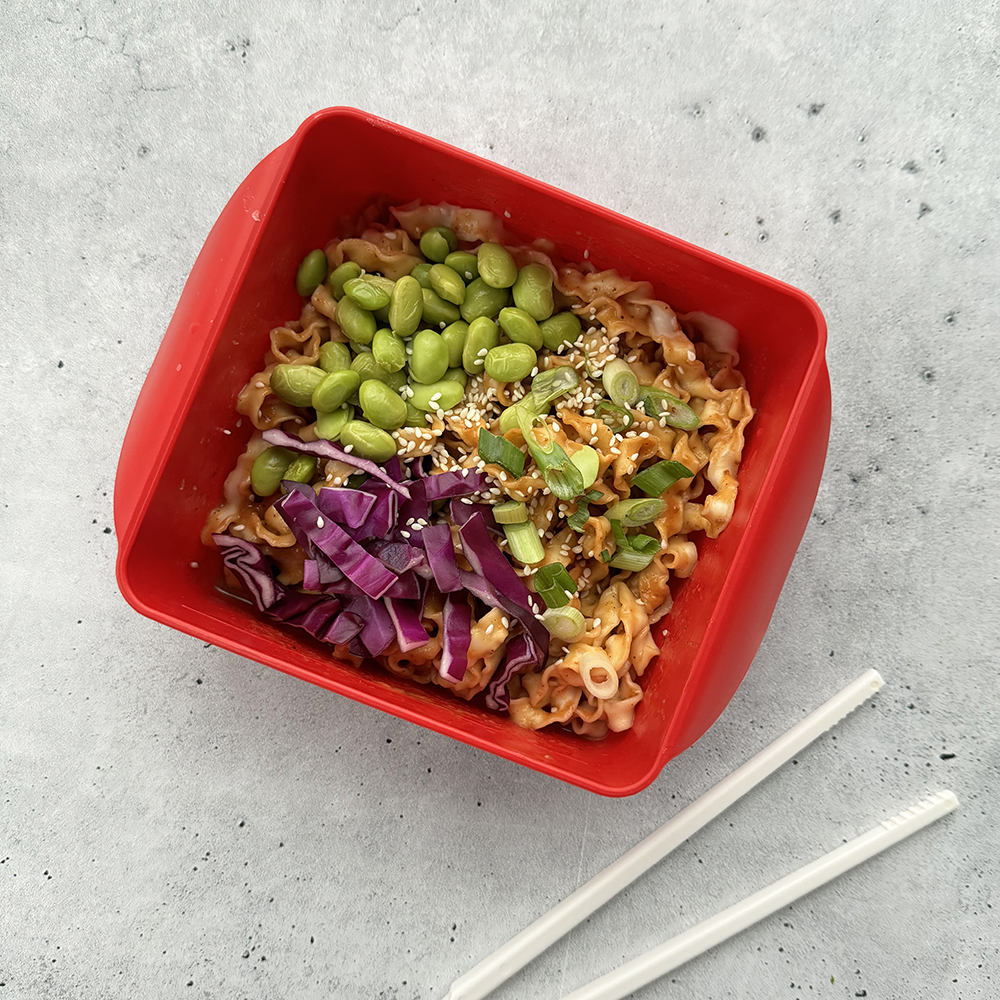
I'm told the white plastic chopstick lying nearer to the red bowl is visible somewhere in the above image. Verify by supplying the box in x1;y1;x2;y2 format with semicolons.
445;670;885;1000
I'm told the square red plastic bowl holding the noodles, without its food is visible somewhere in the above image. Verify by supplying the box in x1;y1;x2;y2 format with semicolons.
115;108;830;796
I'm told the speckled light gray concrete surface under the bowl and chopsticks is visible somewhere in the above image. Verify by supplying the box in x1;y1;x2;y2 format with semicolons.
0;0;1000;1000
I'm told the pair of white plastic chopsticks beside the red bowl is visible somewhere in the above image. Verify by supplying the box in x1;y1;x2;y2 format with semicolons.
445;670;958;1000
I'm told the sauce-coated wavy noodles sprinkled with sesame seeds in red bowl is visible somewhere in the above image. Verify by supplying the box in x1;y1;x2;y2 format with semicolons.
202;203;754;739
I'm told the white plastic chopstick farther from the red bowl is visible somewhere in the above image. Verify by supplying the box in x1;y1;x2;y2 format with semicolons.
562;791;958;1000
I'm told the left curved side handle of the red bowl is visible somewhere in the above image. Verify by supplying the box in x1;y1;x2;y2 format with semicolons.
114;142;288;545
